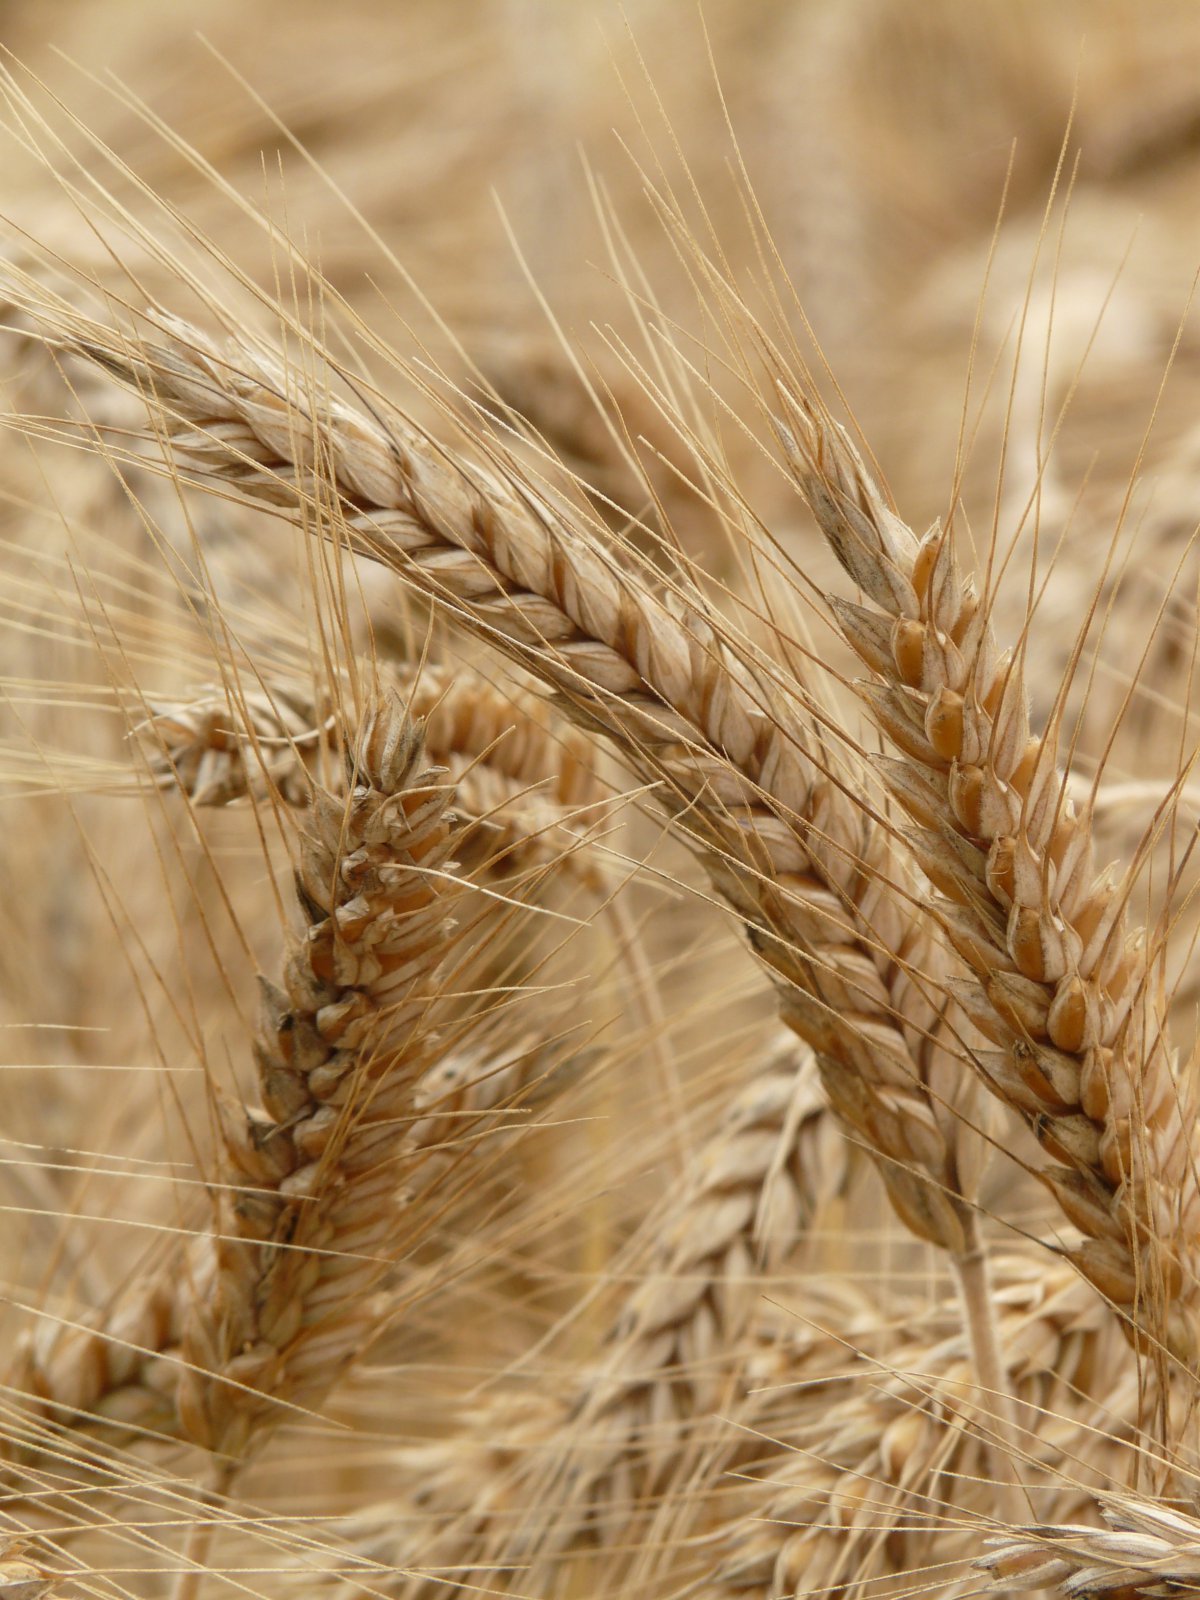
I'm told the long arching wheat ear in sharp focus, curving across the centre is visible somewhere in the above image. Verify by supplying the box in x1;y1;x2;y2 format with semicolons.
46;306;998;1256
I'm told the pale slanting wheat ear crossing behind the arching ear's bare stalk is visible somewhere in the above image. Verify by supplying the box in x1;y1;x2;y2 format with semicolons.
696;1254;1139;1600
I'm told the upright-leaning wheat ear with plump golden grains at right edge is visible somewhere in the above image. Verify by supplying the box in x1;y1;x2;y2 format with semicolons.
779;386;1200;1366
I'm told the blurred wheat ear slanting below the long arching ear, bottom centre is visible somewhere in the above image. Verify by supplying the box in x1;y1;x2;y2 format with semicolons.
502;1034;850;1549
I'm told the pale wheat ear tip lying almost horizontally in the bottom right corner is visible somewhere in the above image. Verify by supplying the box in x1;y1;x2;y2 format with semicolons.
974;1496;1200;1600
